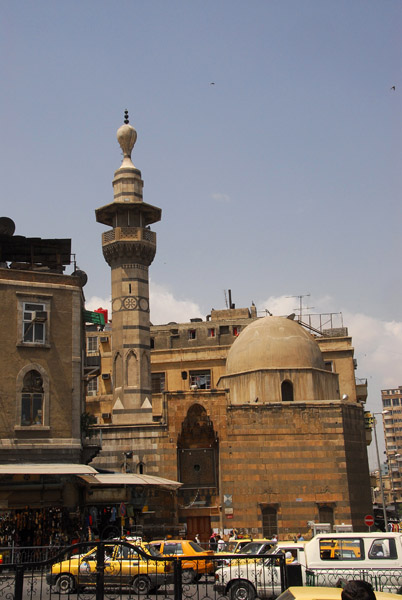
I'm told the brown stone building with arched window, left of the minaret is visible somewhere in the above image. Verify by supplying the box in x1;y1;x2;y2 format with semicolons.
0;225;86;509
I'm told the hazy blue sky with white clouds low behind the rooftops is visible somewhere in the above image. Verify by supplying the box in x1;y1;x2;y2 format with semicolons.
0;0;402;460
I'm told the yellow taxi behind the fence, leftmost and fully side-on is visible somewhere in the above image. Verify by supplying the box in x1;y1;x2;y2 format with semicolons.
46;543;173;594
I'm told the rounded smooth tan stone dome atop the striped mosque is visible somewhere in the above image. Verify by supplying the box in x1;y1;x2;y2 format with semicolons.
226;317;325;375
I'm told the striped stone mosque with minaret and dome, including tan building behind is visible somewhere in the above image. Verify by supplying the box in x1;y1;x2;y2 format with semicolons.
86;113;372;540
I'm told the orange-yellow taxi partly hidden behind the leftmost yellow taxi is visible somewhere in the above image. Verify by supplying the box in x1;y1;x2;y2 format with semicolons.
149;539;215;583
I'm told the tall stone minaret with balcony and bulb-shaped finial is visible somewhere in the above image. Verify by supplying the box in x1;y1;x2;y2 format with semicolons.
95;111;162;425
